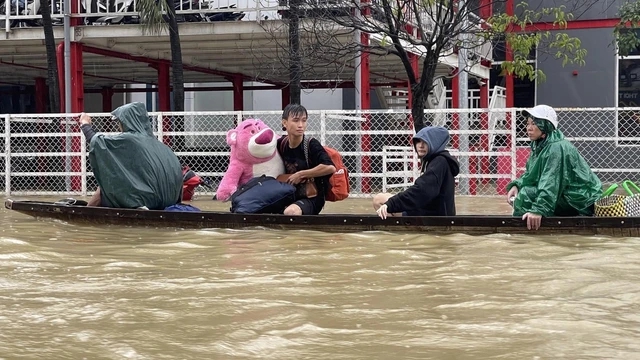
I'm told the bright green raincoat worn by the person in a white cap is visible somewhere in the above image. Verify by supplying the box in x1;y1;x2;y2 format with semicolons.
507;124;602;217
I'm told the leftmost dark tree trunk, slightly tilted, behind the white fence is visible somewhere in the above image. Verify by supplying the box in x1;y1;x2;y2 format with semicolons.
40;0;59;113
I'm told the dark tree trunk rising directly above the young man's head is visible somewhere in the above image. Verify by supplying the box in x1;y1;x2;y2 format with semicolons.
289;0;302;104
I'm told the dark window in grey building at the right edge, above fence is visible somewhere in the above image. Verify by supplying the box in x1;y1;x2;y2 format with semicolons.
617;31;640;146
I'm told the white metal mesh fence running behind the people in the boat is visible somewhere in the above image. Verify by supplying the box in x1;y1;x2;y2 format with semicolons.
0;108;640;197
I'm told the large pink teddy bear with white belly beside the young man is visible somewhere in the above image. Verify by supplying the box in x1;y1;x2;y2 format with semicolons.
216;119;284;201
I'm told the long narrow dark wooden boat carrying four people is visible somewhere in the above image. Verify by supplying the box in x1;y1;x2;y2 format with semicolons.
4;199;640;237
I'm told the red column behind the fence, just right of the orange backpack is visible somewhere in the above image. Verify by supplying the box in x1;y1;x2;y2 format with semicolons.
360;32;371;194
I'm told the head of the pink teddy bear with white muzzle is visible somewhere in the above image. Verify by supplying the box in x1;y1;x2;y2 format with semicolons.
227;119;278;163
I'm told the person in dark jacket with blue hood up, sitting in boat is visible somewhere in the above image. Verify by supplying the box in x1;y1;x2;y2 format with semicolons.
373;126;460;219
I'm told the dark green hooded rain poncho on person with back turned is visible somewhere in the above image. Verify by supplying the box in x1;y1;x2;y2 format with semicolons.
89;103;182;210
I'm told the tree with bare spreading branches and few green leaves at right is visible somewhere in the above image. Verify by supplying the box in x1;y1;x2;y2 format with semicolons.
250;0;598;130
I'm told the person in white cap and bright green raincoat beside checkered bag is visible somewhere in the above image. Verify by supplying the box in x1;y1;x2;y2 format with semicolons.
507;105;602;230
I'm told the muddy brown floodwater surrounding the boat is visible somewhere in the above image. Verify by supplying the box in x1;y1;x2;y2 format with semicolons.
0;199;640;360
